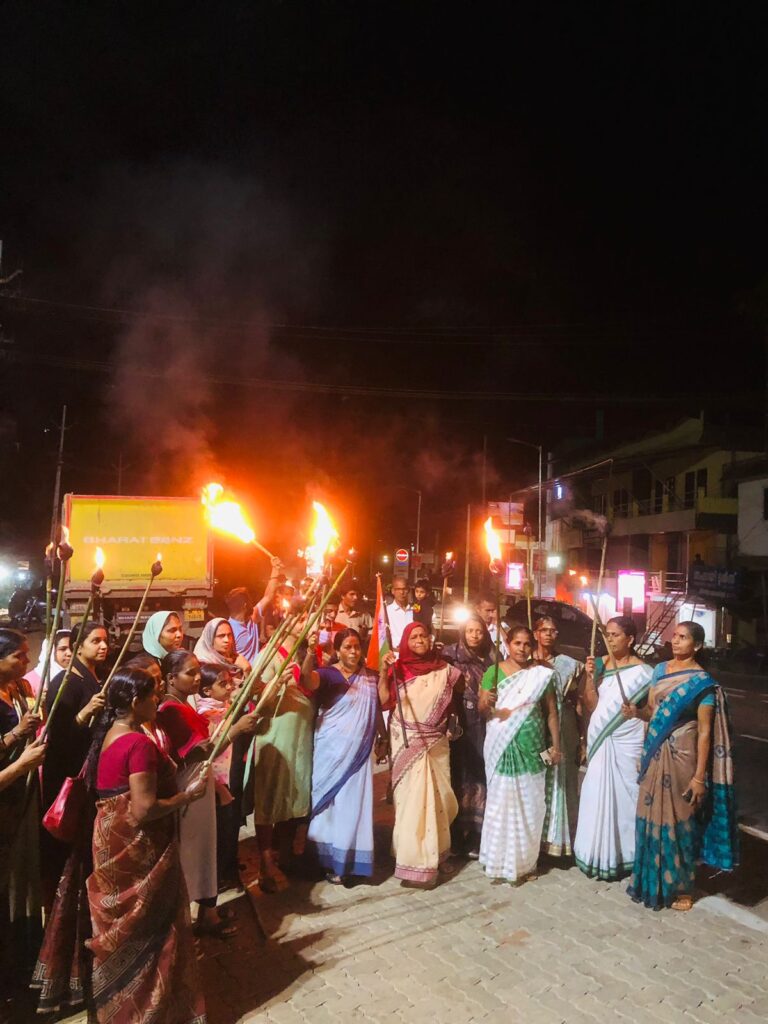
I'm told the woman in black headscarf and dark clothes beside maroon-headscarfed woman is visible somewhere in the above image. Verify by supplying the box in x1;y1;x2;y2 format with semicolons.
442;615;494;860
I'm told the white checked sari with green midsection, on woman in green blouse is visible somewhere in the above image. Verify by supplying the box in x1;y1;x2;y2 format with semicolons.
480;665;555;883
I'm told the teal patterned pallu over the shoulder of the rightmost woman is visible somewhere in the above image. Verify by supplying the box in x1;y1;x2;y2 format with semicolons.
638;670;738;870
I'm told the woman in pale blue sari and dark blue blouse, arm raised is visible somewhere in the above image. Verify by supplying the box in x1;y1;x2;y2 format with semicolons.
302;629;379;885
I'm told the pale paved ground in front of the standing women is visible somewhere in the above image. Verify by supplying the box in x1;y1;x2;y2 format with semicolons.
45;776;768;1024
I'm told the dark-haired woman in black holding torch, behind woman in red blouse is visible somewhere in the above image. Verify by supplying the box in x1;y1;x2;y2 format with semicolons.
41;622;110;911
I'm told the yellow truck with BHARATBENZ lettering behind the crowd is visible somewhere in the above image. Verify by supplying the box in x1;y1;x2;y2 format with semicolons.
62;495;213;646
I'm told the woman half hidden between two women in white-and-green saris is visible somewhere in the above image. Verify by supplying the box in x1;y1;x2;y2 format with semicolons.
534;615;584;857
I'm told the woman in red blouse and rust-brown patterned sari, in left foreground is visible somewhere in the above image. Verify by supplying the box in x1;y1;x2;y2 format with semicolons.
86;669;211;1024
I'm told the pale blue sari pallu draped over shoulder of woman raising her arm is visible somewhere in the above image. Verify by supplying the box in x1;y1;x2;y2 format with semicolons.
311;671;379;815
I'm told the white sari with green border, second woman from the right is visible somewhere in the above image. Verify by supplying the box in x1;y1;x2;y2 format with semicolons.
573;665;653;882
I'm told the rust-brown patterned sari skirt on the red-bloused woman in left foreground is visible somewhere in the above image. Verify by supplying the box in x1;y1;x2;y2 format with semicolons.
87;793;206;1024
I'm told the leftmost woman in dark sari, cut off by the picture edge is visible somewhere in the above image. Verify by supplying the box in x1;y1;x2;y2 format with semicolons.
0;629;42;987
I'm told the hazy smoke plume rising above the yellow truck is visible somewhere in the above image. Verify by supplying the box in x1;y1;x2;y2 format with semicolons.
83;163;312;493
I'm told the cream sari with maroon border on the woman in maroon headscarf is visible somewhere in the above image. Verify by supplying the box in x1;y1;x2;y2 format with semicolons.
389;664;462;884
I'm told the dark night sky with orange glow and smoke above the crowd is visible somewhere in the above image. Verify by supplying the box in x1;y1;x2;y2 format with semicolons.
0;0;768;565
